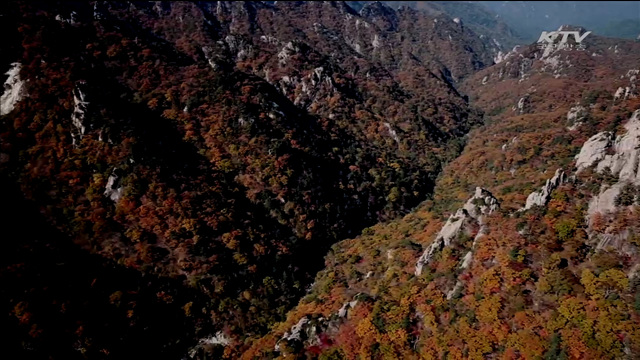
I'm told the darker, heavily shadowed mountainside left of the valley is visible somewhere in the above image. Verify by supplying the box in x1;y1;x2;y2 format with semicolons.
0;2;493;358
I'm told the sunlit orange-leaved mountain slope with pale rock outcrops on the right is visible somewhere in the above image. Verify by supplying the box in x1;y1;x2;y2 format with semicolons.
244;25;640;359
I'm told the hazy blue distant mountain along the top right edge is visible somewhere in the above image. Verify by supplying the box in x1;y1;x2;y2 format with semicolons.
349;1;640;44
